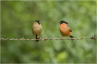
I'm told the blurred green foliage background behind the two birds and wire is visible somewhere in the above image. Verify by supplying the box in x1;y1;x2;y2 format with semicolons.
1;1;97;64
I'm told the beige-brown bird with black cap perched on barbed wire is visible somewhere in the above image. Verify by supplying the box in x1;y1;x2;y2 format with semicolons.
32;20;42;42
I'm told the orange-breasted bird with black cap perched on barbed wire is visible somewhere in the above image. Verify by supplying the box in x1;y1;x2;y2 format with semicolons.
59;21;74;38
